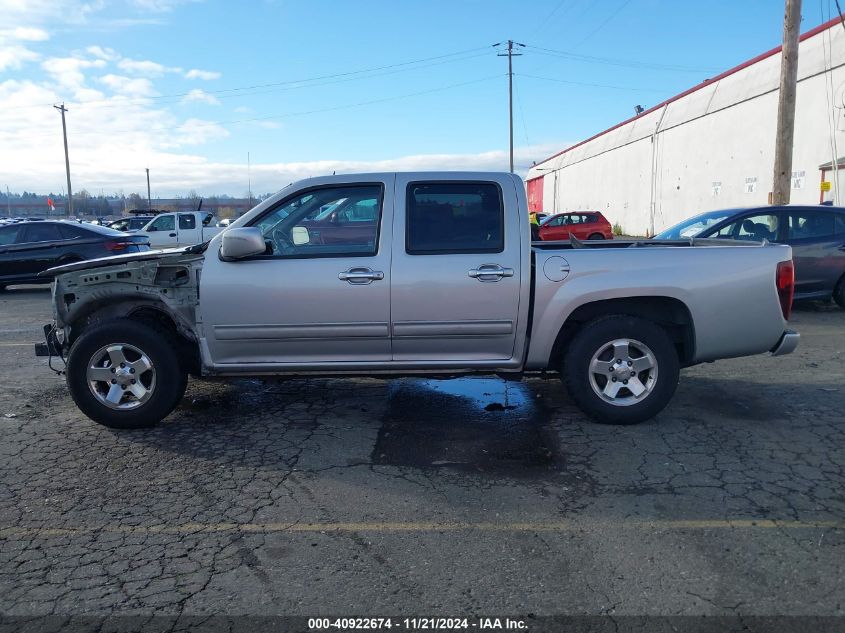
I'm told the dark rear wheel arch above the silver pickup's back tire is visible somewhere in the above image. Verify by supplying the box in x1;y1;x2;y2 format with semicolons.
548;296;695;368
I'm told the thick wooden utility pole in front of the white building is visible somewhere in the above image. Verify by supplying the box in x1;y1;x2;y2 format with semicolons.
772;0;801;204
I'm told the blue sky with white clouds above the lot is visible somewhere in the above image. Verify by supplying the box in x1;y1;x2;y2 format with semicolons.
0;0;828;195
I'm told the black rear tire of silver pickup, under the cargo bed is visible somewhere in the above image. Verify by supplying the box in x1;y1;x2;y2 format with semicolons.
562;315;680;424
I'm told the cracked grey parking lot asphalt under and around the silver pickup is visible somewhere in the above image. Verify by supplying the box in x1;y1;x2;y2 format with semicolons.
0;287;845;616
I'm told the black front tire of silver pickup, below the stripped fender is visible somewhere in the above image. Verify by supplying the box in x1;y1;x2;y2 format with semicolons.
67;319;188;429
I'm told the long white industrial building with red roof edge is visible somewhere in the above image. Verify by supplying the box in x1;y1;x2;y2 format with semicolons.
527;18;845;235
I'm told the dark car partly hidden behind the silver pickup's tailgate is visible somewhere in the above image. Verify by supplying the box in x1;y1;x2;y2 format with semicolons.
654;205;845;308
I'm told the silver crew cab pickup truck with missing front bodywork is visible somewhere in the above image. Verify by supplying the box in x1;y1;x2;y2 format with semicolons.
36;172;798;428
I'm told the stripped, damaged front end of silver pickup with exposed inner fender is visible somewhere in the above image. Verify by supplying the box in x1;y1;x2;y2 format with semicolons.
36;249;204;357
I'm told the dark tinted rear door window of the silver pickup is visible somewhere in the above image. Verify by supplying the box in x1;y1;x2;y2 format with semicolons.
405;182;505;255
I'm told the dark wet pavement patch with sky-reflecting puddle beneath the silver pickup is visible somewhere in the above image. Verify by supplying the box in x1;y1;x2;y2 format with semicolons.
372;378;559;477
